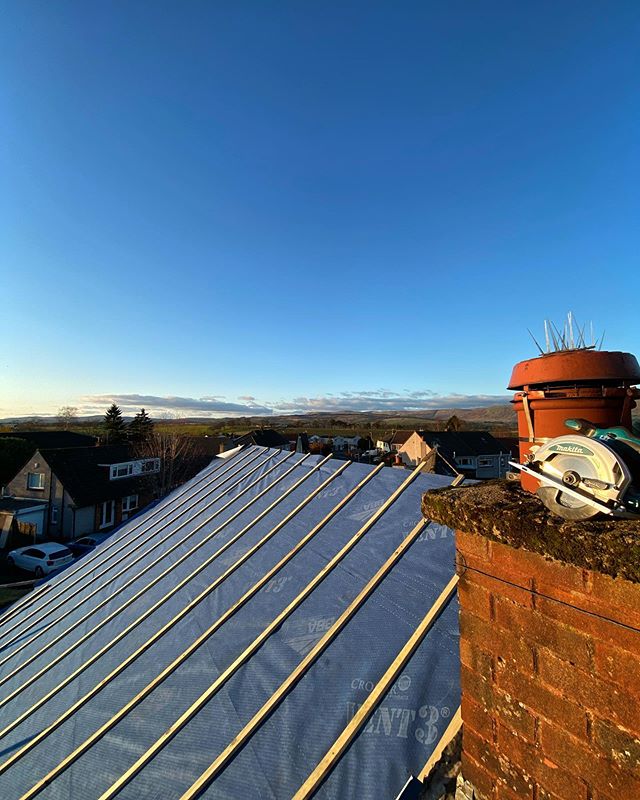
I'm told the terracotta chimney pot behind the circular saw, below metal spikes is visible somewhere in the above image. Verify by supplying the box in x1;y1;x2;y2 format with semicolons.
508;348;640;492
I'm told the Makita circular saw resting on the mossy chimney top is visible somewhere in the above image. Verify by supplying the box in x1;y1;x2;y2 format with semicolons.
511;419;640;520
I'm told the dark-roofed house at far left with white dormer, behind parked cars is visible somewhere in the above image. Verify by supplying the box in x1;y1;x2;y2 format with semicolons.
4;445;160;540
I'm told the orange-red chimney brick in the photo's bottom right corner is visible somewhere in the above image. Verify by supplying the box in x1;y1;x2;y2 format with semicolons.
540;721;640;798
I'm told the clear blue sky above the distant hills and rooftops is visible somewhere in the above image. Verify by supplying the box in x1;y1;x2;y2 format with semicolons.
0;0;640;416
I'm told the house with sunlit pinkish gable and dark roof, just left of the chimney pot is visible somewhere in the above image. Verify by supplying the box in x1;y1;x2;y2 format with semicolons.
398;431;510;478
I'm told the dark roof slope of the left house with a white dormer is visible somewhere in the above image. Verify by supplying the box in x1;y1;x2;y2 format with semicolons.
40;444;149;506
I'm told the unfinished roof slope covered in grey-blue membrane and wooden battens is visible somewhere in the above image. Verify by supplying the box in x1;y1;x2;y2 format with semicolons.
0;447;459;800
